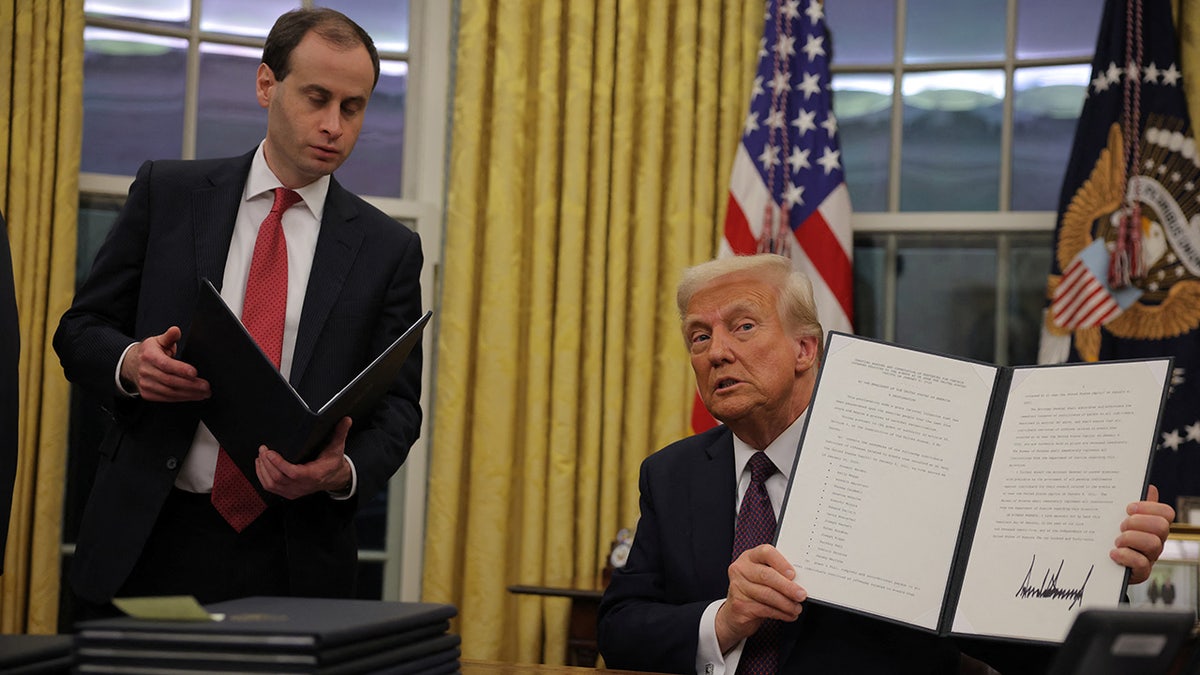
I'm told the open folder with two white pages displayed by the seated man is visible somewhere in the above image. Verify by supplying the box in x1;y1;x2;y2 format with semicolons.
776;331;1171;643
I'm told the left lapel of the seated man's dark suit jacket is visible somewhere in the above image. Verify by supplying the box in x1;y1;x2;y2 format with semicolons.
689;428;738;595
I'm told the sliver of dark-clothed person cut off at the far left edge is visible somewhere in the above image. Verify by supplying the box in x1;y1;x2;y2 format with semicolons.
0;208;20;573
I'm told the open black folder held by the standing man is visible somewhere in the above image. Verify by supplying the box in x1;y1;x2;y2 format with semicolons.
180;279;433;486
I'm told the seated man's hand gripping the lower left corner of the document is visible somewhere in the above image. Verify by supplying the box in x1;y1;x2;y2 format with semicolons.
715;544;809;652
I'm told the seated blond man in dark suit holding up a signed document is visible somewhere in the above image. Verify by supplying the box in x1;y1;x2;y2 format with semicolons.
598;255;1174;675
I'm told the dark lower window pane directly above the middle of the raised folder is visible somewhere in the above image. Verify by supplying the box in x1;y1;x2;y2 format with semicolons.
896;233;996;363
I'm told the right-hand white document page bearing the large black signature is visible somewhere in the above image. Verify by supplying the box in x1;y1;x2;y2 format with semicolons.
953;359;1169;641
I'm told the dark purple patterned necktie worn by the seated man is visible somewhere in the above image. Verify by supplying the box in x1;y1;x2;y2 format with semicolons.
732;452;782;675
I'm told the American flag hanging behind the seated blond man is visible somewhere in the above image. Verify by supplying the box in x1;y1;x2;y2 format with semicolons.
692;0;854;431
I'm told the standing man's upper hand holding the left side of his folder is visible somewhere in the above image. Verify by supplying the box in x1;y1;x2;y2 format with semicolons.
121;325;211;402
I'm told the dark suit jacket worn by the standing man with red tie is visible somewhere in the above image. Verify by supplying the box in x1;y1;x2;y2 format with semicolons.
54;153;422;603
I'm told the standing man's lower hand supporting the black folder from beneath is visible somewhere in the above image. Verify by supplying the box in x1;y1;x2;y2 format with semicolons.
254;417;352;500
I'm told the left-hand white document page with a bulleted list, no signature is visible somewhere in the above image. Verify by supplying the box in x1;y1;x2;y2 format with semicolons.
776;334;997;629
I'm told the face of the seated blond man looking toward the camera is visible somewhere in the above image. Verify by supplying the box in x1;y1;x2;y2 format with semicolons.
684;273;816;439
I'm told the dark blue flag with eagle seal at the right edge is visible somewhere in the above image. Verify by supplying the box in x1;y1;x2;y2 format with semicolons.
1039;0;1200;504
